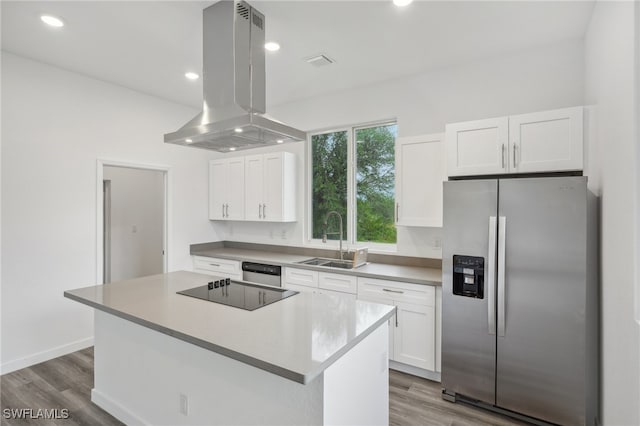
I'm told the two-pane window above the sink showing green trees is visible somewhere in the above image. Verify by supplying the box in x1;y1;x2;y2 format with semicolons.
311;123;397;244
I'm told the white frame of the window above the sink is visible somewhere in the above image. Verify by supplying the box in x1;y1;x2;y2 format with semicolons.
305;118;398;252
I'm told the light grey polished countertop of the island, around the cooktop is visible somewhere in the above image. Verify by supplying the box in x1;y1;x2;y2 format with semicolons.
64;271;395;384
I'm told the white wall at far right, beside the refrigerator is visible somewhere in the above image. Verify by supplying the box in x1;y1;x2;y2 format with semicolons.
585;2;640;425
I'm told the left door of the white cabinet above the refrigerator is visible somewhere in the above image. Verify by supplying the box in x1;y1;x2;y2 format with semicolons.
446;117;509;176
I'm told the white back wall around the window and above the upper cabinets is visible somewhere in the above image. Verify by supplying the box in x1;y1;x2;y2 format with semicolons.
214;40;584;257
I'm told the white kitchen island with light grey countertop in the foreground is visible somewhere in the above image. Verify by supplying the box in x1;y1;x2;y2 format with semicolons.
65;271;395;425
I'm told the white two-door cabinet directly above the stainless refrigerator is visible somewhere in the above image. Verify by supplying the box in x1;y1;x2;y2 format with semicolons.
446;107;583;176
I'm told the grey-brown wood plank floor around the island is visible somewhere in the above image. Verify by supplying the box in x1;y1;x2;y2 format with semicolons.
0;348;522;426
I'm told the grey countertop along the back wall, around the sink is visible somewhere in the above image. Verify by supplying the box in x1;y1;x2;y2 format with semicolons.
191;247;442;286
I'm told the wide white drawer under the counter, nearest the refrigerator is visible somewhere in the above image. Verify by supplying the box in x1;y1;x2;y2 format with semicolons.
358;277;436;306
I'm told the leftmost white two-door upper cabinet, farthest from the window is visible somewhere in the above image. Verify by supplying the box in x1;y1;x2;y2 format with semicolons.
209;157;244;220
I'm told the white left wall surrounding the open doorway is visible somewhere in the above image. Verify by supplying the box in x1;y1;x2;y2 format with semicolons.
1;52;218;372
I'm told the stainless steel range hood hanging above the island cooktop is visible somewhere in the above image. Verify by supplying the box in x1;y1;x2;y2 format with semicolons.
164;0;307;152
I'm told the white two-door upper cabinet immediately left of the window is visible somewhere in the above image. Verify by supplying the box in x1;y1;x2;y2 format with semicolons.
244;152;296;222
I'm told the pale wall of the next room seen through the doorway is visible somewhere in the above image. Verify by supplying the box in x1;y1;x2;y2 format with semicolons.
103;166;164;282
